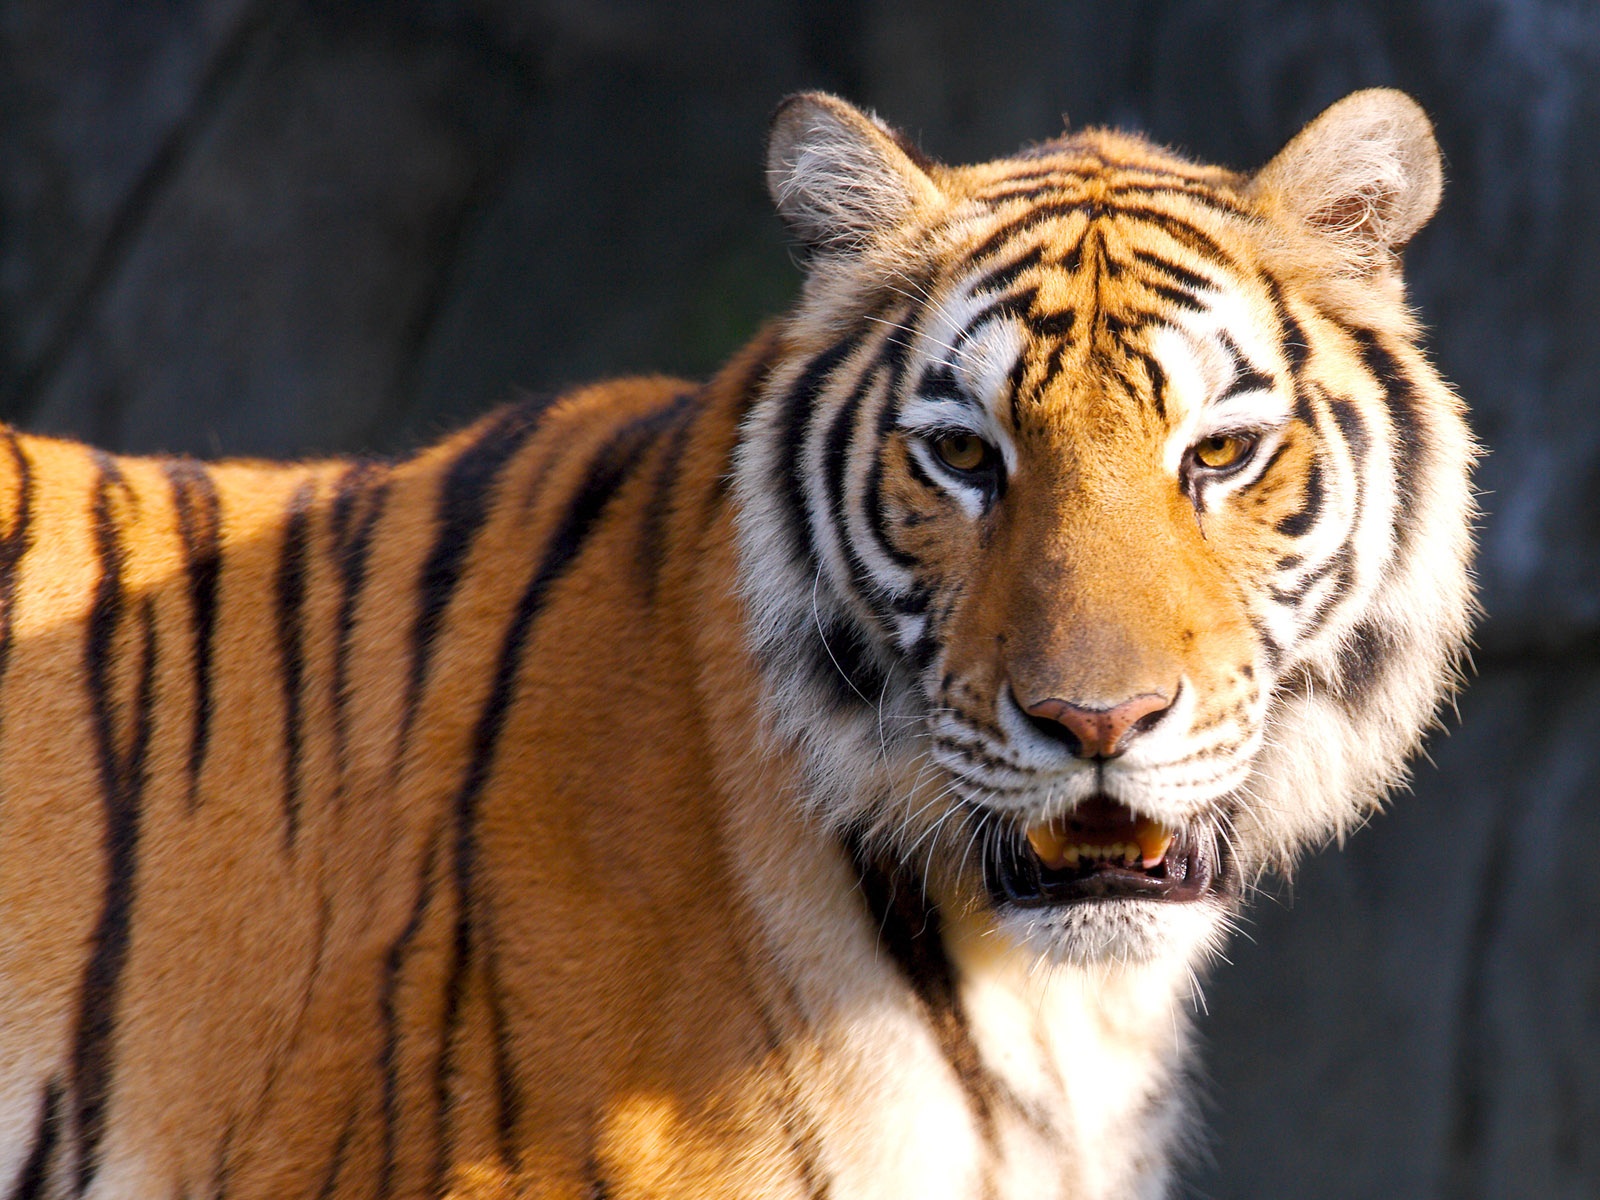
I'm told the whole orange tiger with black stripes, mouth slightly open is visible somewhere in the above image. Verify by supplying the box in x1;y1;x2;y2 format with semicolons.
0;90;1477;1200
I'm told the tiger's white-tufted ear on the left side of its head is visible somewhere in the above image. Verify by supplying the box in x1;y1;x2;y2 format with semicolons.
766;91;942;253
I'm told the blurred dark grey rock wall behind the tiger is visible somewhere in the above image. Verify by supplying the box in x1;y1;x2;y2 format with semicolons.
0;0;1600;1200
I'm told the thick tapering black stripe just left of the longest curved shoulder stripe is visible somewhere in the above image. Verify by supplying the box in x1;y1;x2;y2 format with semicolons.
395;405;539;762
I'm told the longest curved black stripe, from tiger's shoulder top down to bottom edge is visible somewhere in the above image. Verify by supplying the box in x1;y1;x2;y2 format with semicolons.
434;406;674;1190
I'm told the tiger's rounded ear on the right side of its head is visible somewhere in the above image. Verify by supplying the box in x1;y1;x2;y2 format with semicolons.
1250;88;1443;274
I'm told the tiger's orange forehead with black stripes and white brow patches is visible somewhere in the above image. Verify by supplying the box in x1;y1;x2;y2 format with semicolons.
922;190;1283;444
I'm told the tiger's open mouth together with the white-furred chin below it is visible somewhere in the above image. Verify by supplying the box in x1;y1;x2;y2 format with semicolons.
984;797;1238;966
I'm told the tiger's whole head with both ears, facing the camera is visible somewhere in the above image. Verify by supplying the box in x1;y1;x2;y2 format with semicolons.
734;91;1474;963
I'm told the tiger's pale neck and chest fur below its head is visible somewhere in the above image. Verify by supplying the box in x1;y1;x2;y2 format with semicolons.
699;508;1190;1200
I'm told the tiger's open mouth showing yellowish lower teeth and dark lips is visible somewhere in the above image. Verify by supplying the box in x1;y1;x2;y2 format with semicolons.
984;795;1222;909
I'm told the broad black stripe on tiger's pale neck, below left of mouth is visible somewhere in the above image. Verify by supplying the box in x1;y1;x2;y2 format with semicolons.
845;830;995;1147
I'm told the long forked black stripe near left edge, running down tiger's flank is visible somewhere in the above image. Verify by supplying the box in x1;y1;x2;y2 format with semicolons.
72;451;157;1194
